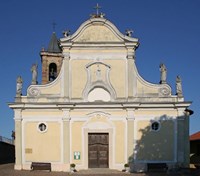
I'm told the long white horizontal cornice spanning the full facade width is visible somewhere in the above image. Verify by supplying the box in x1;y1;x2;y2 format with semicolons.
8;102;191;109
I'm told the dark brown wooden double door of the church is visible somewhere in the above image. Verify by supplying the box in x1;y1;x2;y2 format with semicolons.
88;133;109;168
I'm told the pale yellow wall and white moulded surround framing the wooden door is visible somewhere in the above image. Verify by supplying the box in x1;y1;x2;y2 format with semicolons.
71;115;126;164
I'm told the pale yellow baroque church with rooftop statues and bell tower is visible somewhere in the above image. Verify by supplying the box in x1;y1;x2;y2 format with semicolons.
9;14;191;171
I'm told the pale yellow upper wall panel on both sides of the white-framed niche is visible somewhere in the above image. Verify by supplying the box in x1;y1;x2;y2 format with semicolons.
71;59;126;98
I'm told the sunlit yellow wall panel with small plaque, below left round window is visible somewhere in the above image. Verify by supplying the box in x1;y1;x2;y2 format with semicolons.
24;122;61;162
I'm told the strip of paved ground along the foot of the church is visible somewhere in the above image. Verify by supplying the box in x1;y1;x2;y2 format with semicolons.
0;164;200;176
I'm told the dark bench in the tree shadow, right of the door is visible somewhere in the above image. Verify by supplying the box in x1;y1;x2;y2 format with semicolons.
147;163;168;172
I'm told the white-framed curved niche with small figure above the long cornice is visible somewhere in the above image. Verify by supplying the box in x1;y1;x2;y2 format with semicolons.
83;61;116;101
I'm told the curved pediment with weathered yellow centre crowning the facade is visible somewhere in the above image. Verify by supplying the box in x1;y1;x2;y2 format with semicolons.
61;18;138;46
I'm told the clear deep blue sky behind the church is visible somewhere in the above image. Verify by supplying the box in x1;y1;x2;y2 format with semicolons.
0;0;200;138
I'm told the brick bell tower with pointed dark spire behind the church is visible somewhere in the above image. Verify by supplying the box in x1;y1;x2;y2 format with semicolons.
40;32;63;84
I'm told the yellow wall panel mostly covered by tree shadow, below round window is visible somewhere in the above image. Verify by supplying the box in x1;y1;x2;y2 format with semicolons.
136;120;175;161
